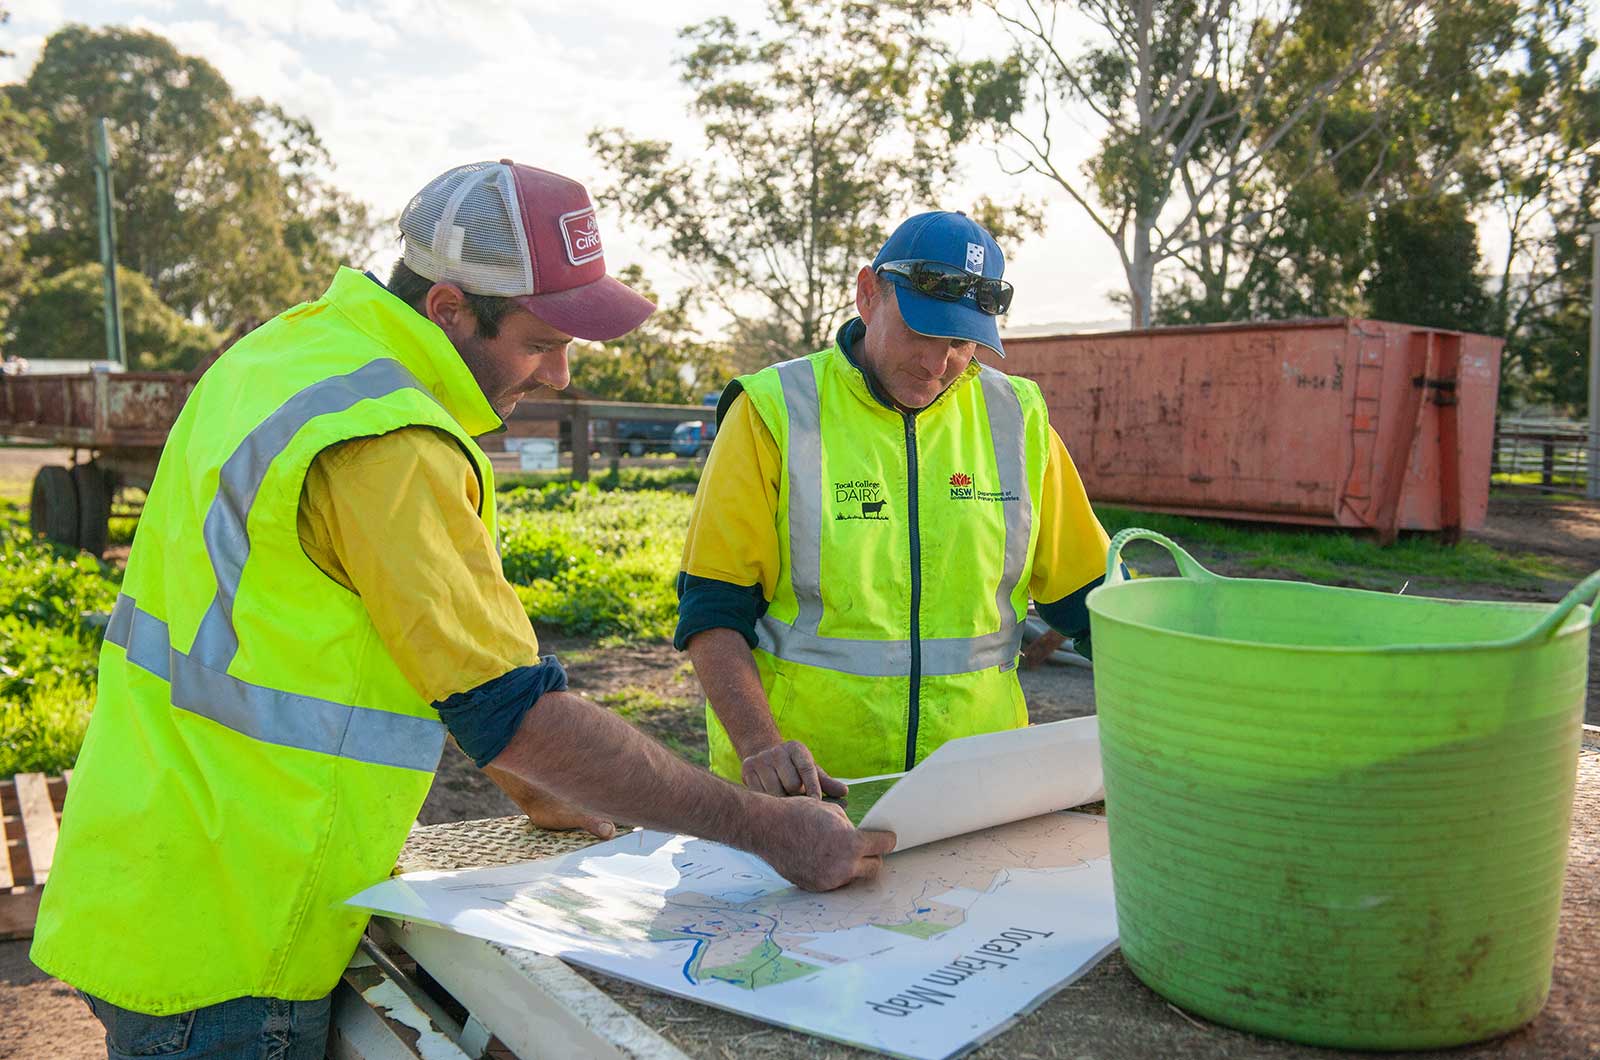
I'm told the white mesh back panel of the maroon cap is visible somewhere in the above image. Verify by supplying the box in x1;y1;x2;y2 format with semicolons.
400;162;533;296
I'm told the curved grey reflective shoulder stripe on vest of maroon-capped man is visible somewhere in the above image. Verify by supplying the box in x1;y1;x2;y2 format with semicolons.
190;359;438;671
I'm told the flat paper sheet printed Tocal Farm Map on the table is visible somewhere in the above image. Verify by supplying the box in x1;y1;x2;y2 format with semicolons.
350;813;1117;1060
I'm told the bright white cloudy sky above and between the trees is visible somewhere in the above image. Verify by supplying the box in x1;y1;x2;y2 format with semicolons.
0;0;1600;336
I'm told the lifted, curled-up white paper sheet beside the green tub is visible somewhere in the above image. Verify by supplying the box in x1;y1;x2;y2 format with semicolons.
846;717;1106;850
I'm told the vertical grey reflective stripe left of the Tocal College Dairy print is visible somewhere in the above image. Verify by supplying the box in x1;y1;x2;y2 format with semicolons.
778;357;822;634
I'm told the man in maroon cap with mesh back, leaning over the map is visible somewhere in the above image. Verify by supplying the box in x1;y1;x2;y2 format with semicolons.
32;162;894;1058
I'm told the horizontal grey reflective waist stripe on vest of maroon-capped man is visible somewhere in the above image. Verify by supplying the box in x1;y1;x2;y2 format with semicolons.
106;596;445;773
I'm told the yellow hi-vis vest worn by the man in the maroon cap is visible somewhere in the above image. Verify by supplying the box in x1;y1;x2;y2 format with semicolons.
30;269;499;1015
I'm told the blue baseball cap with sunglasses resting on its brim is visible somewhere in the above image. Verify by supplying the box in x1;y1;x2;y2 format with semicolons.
872;210;1005;357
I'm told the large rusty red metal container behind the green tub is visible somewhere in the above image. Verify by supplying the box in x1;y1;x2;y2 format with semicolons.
986;319;1504;541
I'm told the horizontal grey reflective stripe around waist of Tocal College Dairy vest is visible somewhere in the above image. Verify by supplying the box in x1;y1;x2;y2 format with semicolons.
755;615;1022;677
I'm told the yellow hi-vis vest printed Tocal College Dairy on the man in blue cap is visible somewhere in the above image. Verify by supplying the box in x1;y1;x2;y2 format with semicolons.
706;344;1050;780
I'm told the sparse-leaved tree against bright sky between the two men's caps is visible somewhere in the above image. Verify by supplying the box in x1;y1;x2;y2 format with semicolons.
589;0;1037;360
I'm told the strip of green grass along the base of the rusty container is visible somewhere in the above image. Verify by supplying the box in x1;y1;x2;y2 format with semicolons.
1096;508;1576;589
